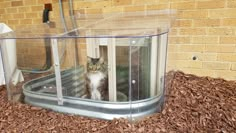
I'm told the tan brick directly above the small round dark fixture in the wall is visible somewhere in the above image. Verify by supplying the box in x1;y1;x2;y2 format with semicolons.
178;45;205;52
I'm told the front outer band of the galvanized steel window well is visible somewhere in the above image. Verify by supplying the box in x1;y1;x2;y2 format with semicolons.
25;94;162;120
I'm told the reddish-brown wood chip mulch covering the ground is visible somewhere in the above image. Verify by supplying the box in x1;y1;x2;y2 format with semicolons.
0;72;236;133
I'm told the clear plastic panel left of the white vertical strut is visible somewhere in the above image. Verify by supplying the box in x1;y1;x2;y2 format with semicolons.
1;34;56;102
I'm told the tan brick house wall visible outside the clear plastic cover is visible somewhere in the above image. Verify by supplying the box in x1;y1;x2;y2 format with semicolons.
0;0;236;80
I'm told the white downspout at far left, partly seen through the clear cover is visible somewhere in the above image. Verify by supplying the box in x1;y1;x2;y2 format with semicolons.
0;23;24;85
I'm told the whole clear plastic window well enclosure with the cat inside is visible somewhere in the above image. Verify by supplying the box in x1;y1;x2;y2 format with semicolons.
0;10;175;120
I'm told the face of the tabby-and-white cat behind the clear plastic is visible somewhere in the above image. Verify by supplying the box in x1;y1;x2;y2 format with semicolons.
87;57;104;72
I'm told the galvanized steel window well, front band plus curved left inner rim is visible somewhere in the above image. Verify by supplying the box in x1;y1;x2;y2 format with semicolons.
23;68;163;120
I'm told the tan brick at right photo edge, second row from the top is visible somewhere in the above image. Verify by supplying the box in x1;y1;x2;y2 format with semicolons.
209;8;236;18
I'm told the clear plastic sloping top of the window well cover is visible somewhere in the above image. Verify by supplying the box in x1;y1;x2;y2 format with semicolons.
0;10;176;39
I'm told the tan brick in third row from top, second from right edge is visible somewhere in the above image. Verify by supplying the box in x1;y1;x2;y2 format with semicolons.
193;19;220;27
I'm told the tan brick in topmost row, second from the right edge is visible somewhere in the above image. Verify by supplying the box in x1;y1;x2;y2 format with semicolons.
197;0;226;9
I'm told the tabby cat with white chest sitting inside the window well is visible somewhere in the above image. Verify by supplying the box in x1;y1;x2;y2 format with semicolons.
86;57;108;101
